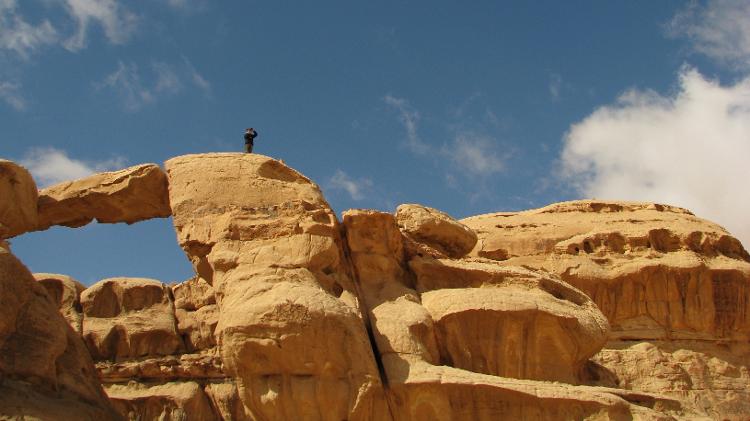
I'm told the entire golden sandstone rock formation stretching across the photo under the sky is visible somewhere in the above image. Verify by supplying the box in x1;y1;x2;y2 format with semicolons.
0;153;750;421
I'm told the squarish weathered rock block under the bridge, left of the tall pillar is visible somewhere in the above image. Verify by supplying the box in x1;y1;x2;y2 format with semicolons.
81;278;184;360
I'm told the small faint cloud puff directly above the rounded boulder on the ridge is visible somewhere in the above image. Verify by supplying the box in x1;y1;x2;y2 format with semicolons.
441;132;505;177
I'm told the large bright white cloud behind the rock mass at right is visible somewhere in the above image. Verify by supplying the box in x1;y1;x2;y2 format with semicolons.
562;67;750;247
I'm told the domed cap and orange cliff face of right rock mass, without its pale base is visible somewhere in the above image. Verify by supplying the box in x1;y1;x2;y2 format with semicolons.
462;201;750;341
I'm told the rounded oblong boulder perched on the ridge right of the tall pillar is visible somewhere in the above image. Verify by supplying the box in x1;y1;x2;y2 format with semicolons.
396;204;477;258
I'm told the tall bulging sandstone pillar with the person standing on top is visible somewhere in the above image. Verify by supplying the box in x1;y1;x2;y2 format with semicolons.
166;154;388;420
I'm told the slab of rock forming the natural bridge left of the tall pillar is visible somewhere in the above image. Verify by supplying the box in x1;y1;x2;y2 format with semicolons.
37;164;171;230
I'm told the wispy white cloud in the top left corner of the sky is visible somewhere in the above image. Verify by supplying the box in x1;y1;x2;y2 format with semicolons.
0;0;58;59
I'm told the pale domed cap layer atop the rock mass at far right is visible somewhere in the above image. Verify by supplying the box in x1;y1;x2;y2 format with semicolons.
461;200;750;261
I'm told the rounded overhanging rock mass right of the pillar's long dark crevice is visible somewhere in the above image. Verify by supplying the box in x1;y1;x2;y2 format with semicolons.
344;210;658;420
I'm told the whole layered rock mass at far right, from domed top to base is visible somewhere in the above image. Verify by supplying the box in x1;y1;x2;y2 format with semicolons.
462;201;750;419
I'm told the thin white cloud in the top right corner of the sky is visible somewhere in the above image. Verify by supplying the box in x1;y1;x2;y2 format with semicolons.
667;0;750;70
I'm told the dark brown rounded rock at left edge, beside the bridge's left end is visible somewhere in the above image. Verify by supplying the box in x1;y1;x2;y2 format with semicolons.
0;159;37;239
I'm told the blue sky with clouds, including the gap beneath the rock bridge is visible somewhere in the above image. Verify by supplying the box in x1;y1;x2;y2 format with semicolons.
0;0;750;284
